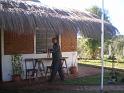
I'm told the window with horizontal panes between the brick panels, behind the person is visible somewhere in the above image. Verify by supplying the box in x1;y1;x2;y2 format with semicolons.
36;31;55;54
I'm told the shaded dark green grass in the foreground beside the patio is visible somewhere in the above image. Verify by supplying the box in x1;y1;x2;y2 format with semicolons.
64;71;124;85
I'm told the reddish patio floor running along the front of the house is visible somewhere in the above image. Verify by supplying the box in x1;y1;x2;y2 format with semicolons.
0;65;100;90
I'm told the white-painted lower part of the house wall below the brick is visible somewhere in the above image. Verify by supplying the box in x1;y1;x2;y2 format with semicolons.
2;52;77;81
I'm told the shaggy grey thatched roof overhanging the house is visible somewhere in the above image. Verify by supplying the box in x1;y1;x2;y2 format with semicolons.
0;0;117;38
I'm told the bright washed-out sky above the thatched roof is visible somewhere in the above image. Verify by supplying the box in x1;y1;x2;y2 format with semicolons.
40;0;124;35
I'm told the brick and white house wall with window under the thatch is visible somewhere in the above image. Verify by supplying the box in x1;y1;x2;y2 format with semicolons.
1;27;77;81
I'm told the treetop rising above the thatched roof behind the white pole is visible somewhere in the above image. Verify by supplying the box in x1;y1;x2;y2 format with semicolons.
86;6;110;22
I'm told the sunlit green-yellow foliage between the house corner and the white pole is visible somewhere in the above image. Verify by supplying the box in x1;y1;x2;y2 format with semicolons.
77;37;100;59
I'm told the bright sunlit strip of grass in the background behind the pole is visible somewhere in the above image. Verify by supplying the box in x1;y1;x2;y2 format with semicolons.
79;60;124;70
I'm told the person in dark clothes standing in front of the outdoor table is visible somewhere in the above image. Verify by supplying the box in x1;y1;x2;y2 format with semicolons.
49;38;64;82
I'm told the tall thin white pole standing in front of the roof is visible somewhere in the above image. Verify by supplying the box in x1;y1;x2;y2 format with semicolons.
101;0;104;93
